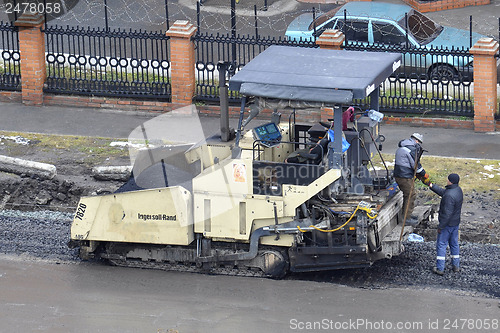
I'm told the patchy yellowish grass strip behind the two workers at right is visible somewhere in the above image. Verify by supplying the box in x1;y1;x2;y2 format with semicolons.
374;154;500;200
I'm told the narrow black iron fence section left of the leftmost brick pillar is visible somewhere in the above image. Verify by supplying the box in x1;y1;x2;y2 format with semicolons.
0;22;21;90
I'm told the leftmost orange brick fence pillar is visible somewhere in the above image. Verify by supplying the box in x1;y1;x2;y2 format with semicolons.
14;11;47;105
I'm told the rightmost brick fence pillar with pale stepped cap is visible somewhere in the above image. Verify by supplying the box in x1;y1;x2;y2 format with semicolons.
470;38;499;132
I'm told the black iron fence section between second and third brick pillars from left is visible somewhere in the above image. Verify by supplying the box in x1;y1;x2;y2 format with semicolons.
193;33;318;102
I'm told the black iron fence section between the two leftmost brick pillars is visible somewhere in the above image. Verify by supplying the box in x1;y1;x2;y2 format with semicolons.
44;26;171;100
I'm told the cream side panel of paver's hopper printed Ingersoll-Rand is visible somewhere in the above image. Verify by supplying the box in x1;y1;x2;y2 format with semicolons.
71;186;194;245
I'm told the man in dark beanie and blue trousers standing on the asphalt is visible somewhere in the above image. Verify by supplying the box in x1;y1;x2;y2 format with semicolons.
429;173;464;275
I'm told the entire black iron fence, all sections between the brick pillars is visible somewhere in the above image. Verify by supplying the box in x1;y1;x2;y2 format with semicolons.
0;18;494;119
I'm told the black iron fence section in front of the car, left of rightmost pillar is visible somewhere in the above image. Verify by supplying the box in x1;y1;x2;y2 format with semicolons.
345;42;474;117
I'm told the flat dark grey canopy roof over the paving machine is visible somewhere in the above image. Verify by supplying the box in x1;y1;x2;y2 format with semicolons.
229;45;401;104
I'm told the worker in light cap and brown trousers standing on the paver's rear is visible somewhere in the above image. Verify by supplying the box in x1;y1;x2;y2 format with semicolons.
394;133;430;225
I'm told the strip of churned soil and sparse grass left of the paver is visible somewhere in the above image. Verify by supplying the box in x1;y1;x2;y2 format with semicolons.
0;136;130;212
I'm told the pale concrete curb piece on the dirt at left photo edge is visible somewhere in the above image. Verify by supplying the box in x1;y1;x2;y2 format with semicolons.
0;155;57;179
